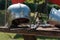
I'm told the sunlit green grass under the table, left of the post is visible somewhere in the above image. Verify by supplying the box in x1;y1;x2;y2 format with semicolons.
0;32;23;40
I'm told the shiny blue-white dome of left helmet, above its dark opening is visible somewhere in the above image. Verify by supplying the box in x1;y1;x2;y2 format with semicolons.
8;3;30;19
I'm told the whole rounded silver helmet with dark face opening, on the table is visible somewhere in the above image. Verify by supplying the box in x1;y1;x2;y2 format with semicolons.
7;3;30;26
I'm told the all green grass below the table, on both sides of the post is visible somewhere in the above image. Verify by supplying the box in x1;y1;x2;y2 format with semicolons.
0;32;60;40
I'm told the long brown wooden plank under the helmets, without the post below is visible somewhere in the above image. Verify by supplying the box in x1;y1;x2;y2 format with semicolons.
0;28;60;38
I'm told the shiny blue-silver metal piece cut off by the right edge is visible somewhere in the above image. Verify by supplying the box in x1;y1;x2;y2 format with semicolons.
49;8;60;22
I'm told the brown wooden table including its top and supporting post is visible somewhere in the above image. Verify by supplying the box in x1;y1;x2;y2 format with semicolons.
0;27;60;40
